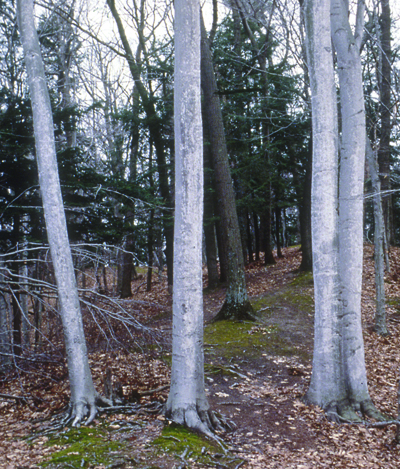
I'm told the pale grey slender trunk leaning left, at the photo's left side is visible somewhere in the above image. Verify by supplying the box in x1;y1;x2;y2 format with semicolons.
17;0;104;425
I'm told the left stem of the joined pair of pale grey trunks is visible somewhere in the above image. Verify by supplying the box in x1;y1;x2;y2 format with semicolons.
304;0;345;413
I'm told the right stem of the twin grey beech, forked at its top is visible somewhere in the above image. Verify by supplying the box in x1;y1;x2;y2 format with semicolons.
331;0;382;418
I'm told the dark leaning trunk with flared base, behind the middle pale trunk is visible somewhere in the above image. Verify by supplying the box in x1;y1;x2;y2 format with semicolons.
201;15;254;320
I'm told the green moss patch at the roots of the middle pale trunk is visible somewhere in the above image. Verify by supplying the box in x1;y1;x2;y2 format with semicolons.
152;423;241;468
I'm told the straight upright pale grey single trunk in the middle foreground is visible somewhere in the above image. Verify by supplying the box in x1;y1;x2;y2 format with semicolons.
166;0;216;435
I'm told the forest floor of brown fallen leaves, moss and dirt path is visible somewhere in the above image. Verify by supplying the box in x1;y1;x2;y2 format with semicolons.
0;245;400;469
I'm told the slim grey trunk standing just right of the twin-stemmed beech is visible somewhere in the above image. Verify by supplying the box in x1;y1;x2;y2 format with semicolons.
366;140;389;335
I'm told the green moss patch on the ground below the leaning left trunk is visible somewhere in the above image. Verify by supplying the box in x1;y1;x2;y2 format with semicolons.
42;427;123;468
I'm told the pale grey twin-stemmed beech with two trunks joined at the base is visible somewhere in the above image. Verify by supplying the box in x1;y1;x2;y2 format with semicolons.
305;0;381;421
